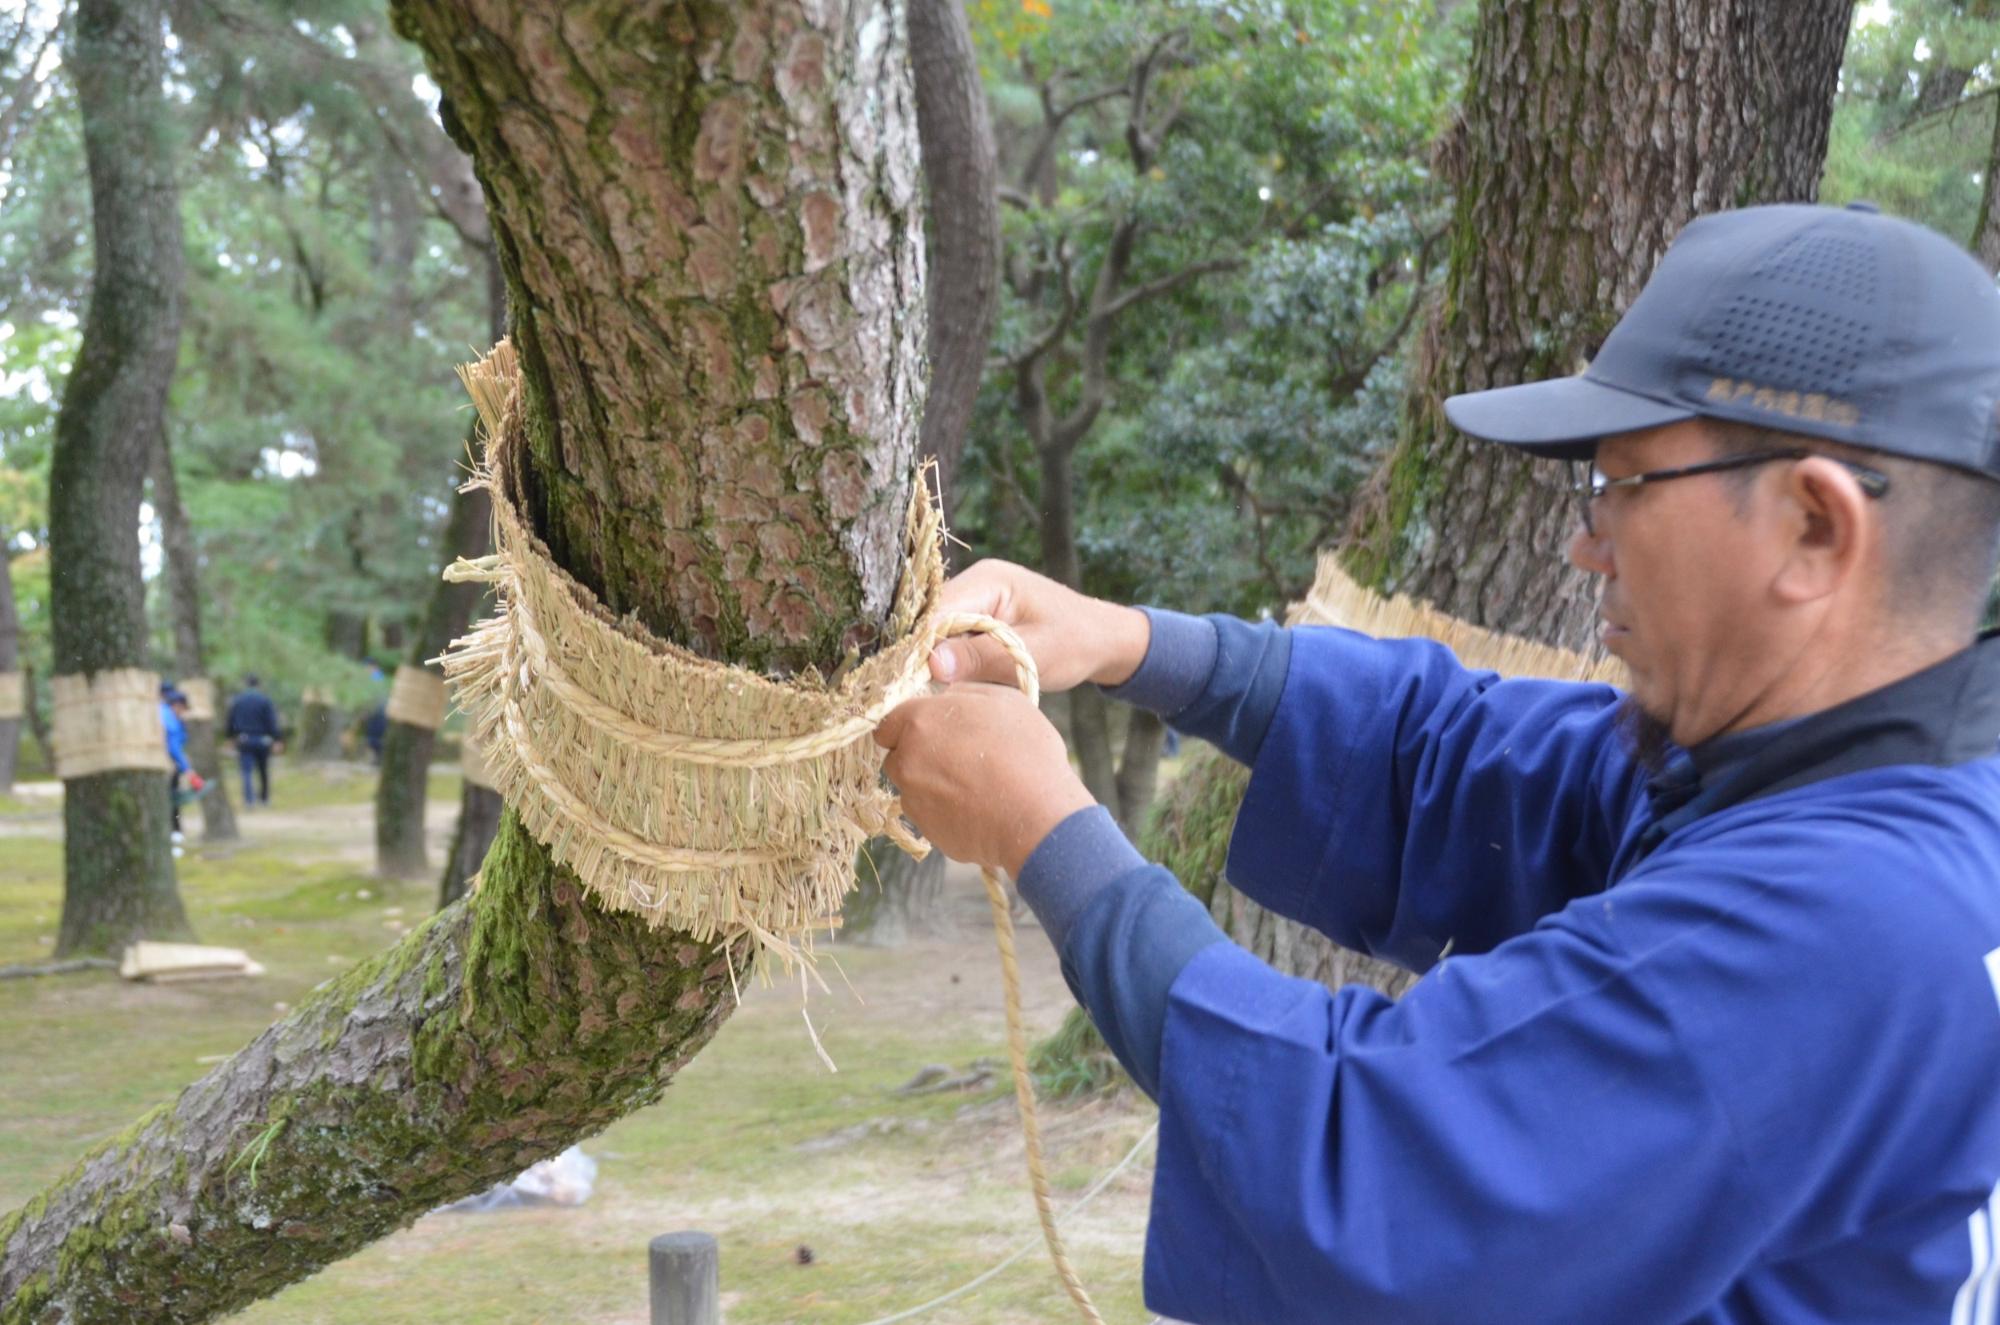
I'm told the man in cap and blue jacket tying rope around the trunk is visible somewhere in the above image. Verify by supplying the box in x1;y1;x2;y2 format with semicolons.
878;206;2000;1325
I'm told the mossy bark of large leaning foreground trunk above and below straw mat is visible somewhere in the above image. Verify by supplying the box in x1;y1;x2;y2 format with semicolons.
0;0;922;1323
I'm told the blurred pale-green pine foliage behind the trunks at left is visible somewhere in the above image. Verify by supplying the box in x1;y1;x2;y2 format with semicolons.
0;0;488;728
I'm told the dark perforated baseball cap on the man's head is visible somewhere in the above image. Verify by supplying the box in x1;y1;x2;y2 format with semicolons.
1444;202;2000;478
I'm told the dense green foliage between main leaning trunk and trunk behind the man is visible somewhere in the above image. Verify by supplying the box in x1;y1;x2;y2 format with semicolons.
960;0;1464;610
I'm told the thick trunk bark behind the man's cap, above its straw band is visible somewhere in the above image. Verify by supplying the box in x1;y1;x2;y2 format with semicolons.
1352;0;1852;648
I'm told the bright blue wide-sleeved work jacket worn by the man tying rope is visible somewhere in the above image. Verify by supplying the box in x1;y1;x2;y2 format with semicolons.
1064;624;2000;1325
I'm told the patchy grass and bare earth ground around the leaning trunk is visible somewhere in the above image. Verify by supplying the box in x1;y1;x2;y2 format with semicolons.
0;769;1152;1325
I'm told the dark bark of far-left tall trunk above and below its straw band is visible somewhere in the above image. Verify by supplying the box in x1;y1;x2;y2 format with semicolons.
48;0;188;957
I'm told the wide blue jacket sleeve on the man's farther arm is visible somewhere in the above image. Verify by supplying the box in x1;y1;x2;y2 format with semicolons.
1226;626;1644;971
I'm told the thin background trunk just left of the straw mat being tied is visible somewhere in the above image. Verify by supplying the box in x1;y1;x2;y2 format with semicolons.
376;470;492;879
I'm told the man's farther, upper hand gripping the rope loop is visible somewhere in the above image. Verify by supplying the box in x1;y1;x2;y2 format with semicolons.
930;560;1152;691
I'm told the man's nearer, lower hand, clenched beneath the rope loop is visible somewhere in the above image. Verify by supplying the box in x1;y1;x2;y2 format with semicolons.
874;684;1094;877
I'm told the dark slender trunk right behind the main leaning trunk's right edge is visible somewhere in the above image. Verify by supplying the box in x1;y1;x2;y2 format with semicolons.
910;0;1000;522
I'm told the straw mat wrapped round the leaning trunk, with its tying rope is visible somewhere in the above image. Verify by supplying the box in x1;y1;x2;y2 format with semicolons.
440;340;1102;1325
